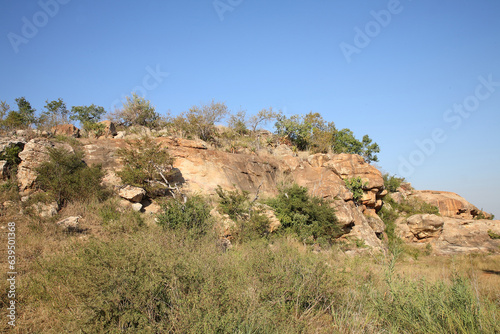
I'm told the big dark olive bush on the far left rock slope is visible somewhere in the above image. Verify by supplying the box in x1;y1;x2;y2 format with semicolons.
36;148;106;205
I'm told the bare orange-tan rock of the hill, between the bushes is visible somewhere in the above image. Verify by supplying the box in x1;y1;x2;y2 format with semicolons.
0;128;500;254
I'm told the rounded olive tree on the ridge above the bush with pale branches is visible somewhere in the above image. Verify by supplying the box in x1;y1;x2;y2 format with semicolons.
116;93;160;128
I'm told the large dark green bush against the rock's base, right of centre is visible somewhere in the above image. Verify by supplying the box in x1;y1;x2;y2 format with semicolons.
266;184;341;242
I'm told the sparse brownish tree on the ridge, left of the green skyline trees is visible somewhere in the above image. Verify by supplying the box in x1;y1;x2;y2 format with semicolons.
184;100;229;140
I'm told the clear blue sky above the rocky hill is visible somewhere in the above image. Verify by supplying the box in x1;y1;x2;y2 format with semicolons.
0;0;500;218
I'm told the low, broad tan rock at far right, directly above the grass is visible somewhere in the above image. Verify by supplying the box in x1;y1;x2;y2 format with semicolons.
396;214;500;254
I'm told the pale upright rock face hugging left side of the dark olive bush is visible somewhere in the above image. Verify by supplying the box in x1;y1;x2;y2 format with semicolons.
17;138;73;196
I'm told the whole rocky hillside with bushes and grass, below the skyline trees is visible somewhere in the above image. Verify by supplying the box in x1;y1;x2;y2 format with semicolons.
0;122;500;333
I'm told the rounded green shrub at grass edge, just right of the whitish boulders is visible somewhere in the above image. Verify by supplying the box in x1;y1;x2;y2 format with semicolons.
157;196;213;234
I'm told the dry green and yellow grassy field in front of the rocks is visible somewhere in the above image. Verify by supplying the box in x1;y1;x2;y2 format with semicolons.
0;196;500;333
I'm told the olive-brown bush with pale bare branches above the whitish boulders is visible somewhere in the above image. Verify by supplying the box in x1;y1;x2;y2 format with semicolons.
117;137;174;196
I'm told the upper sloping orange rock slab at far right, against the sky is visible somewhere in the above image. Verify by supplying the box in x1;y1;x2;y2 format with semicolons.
409;190;491;219
